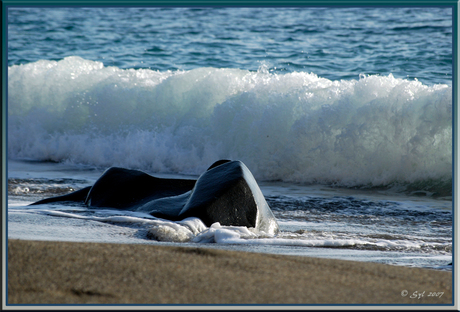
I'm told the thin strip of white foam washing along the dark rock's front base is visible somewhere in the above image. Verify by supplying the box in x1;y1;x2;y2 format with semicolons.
10;207;451;254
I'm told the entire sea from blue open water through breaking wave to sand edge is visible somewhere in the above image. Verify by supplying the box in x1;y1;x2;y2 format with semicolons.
7;7;452;270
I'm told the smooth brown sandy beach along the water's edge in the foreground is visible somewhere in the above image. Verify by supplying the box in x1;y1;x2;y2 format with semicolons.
7;240;452;305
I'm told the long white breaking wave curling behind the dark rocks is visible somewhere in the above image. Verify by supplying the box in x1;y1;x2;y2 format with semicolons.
8;57;452;186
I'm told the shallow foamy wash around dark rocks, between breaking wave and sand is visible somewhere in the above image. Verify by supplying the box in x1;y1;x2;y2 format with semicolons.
8;160;452;270
